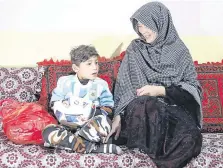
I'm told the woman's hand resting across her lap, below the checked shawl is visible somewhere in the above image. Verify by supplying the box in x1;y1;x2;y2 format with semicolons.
136;85;166;96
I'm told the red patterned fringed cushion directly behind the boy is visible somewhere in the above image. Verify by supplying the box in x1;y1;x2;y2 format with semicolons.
37;55;123;111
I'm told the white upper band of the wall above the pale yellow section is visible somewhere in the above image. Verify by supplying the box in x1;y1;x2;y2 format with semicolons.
0;0;223;35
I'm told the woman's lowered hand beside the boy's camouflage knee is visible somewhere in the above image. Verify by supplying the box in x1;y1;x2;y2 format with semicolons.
103;115;121;143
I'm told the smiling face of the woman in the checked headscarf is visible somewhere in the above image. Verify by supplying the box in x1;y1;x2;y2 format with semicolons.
138;23;157;43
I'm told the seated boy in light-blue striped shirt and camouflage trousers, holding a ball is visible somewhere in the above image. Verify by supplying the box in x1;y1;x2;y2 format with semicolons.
43;45;122;154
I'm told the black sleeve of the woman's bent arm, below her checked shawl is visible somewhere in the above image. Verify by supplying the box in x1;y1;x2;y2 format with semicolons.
165;85;199;122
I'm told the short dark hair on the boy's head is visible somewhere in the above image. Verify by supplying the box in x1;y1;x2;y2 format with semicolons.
70;45;99;66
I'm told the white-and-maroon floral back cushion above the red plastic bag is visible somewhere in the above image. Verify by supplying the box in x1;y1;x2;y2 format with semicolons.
0;67;43;102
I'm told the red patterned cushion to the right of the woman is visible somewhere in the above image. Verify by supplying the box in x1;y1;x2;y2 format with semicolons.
195;62;223;132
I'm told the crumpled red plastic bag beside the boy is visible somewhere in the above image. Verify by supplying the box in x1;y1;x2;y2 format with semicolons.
0;99;57;144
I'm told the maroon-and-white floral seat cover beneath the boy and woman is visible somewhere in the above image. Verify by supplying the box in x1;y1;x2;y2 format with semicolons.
0;119;223;168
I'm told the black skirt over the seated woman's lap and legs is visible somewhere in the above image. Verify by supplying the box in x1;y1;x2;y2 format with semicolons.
121;96;202;167
